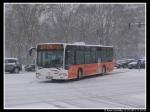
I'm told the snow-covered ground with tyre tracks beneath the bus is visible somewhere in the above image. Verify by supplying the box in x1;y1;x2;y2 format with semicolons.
4;69;146;109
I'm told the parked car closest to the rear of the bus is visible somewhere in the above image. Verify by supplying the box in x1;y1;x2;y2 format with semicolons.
116;59;135;68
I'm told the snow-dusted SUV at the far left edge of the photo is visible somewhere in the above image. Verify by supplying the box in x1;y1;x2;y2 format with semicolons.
5;58;22;73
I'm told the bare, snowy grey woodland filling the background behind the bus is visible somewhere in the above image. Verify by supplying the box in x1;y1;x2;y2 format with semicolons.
5;4;145;63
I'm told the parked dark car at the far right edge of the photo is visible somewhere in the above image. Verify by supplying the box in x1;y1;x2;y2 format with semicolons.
128;59;145;69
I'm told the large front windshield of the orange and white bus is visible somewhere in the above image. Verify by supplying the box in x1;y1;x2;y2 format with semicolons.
37;49;63;68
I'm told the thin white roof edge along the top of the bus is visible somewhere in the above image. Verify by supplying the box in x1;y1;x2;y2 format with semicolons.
38;43;113;47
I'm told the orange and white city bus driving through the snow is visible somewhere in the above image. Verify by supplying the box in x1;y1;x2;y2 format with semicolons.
36;43;114;80
